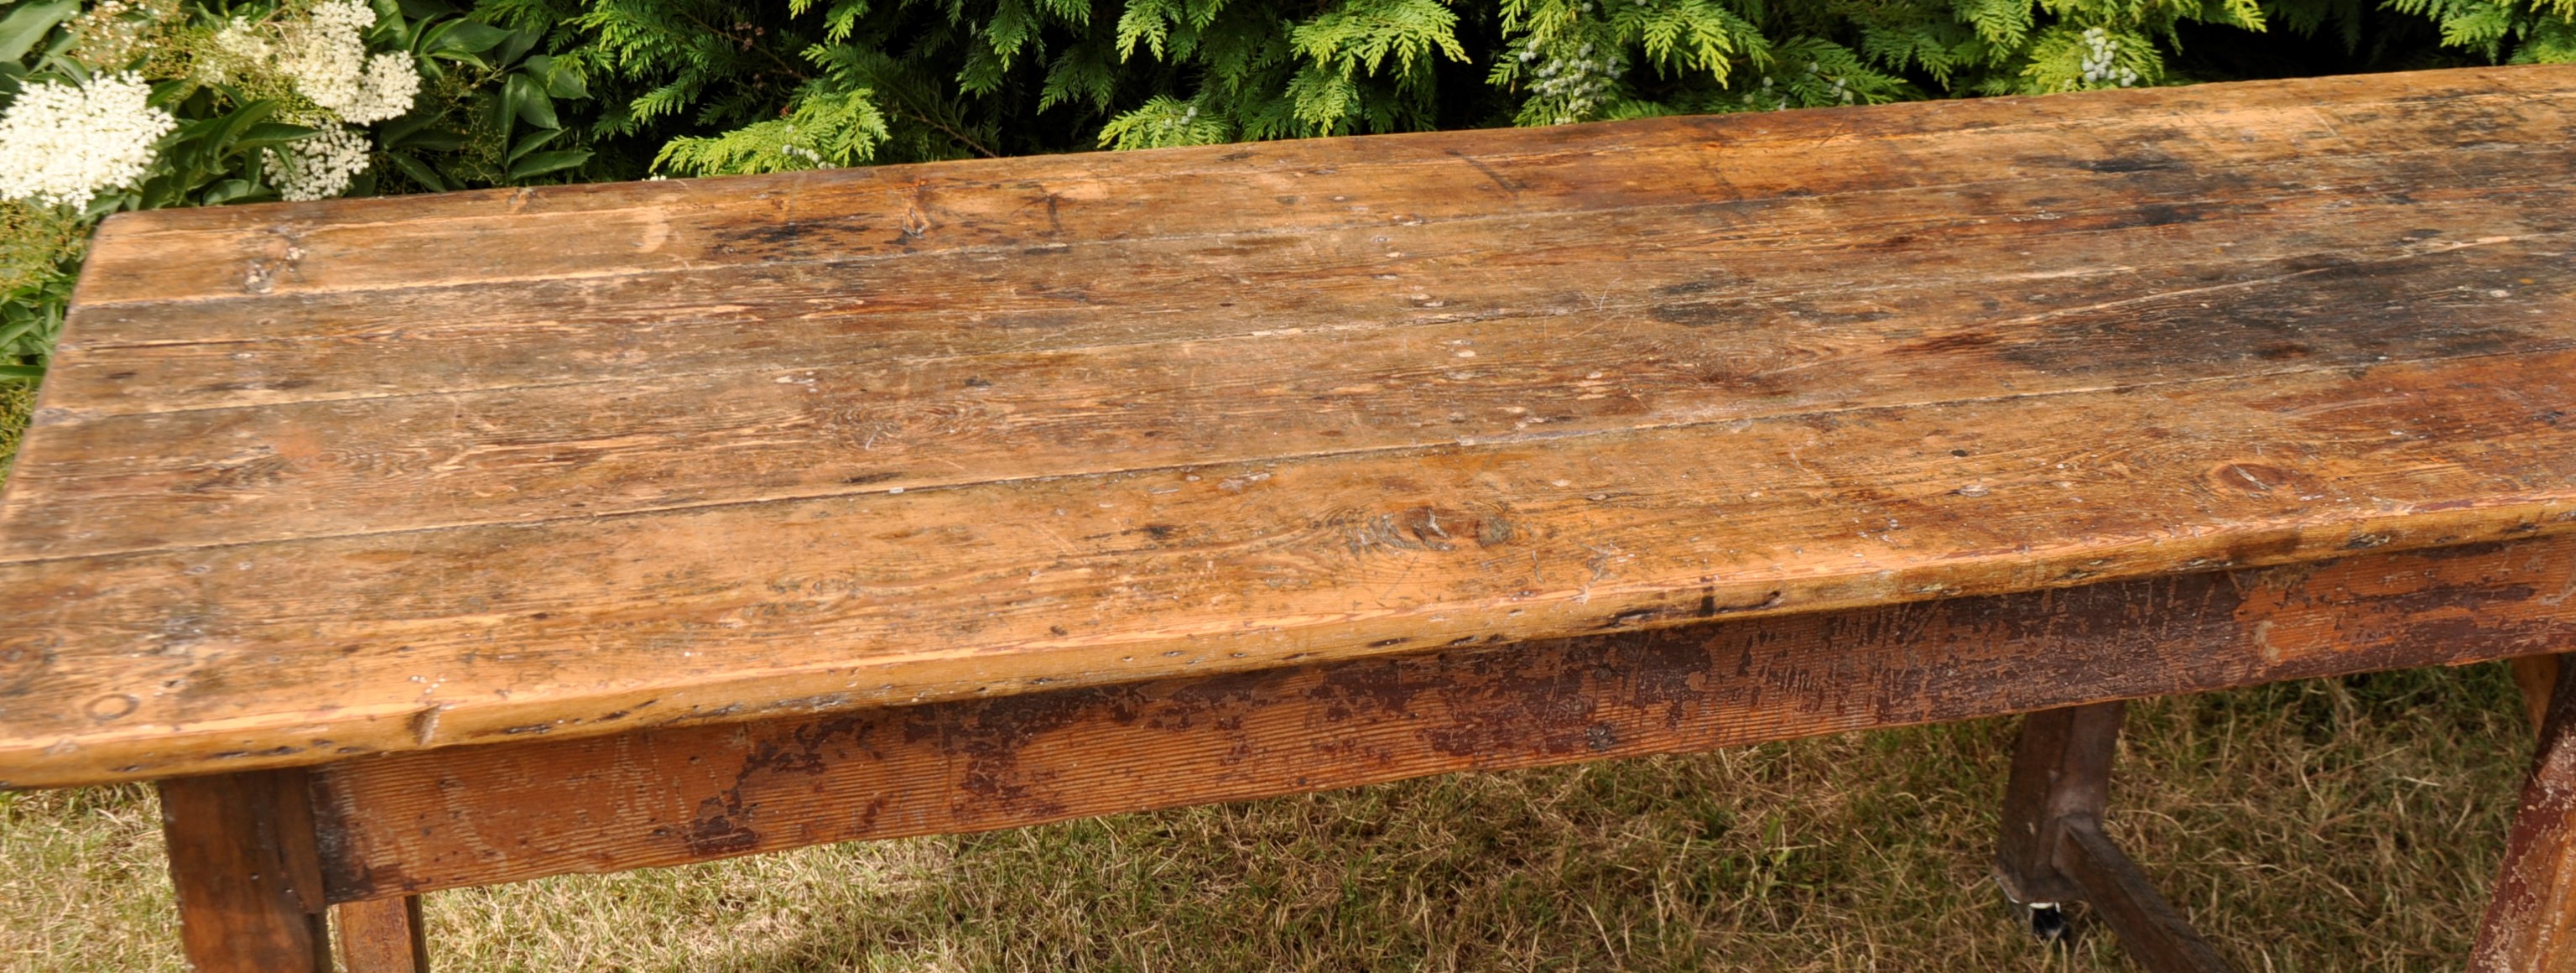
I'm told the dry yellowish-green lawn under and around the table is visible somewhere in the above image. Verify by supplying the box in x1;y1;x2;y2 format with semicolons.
0;381;2530;973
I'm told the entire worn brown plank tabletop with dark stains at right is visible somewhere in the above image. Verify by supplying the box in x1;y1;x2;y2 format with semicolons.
0;67;2576;785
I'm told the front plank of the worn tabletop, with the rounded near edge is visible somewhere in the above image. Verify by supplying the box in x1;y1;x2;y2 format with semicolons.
15;342;2576;785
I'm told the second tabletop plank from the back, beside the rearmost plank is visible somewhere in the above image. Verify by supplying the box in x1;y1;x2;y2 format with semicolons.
54;138;2568;417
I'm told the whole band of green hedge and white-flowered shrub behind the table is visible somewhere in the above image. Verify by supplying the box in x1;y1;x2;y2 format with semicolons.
0;0;2576;378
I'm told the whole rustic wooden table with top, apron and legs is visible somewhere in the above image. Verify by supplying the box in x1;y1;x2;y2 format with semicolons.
0;67;2576;970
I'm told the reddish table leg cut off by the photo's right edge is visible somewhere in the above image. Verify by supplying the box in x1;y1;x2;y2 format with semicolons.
2468;657;2576;973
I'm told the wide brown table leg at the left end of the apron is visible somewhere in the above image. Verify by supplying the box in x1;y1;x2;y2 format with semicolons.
159;770;330;973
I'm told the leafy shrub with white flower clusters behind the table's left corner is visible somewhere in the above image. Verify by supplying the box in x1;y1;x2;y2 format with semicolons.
0;0;590;378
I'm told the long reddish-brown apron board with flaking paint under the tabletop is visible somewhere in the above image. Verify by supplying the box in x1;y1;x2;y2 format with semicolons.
317;538;2576;901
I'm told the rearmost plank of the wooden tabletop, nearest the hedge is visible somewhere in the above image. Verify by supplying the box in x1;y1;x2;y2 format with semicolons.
60;67;2576;304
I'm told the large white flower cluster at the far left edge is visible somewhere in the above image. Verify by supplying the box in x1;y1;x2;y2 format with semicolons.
0;72;178;206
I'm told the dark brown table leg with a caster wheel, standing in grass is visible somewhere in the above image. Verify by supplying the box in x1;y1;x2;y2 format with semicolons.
1994;703;2228;973
